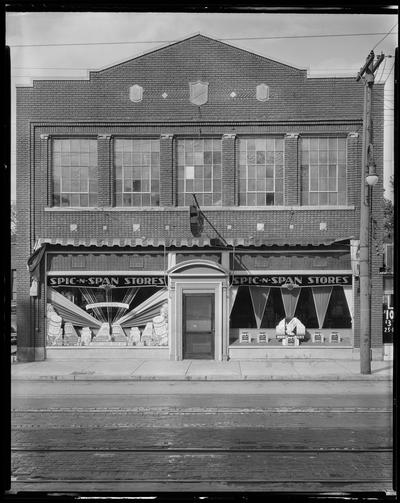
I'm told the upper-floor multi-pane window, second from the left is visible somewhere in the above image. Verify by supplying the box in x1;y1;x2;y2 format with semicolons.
114;139;160;206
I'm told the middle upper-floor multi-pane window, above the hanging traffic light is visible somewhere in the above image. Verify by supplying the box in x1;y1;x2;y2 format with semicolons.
178;138;222;206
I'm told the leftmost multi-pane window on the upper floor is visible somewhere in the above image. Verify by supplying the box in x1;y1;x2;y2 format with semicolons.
52;138;97;207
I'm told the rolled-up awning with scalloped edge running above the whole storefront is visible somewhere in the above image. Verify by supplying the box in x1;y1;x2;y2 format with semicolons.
34;236;353;251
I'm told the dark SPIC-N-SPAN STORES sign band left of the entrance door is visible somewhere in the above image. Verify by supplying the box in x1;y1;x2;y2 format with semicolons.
47;276;167;288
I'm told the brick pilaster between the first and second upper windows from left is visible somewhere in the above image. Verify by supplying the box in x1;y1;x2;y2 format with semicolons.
97;133;114;208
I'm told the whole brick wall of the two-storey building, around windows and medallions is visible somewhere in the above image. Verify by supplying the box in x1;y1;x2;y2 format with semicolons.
16;36;383;359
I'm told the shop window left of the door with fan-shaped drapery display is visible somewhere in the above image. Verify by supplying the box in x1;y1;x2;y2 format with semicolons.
47;281;168;346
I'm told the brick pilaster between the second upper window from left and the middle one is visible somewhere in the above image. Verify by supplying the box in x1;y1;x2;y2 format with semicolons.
160;133;176;206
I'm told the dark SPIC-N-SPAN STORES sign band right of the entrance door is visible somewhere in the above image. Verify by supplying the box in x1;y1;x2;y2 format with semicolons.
232;274;352;288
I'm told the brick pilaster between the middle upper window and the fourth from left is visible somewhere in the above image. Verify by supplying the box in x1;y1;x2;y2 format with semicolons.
222;133;238;206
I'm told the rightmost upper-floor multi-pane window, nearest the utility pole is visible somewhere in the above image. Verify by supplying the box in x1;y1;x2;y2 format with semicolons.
301;137;347;206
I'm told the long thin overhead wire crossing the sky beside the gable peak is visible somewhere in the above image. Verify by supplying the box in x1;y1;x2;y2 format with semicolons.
9;31;397;48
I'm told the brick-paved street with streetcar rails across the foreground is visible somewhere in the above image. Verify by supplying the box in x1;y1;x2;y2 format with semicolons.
11;400;393;491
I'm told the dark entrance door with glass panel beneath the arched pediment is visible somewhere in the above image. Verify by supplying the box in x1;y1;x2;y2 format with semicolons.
182;293;214;360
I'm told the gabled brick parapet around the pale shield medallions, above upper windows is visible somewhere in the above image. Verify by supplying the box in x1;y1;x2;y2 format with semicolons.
14;36;363;121
